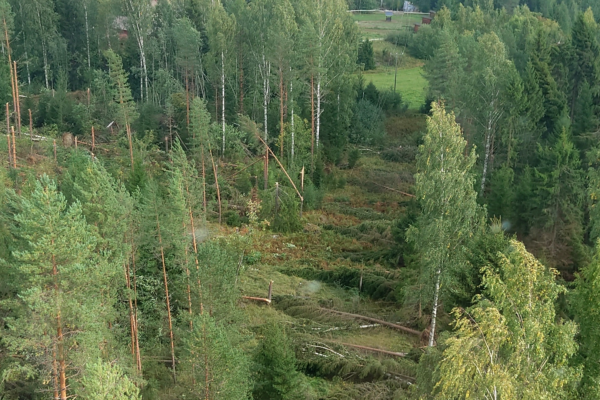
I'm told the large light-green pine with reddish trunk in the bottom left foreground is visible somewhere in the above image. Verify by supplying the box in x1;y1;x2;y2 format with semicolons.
5;175;113;400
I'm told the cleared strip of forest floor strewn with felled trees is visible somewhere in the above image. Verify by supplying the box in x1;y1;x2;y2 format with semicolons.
234;112;426;397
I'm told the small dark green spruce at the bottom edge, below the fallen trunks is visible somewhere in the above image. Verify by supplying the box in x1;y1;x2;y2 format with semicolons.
252;322;302;400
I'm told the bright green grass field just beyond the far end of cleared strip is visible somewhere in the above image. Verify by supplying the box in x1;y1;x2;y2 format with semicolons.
363;67;427;110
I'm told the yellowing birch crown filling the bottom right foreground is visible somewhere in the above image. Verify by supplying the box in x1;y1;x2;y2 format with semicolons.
434;241;579;399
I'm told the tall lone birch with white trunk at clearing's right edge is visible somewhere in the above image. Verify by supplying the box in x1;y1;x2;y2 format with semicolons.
408;104;481;346
